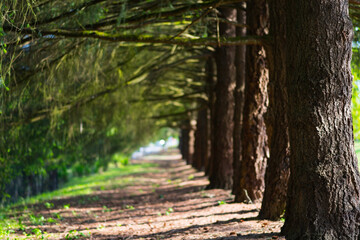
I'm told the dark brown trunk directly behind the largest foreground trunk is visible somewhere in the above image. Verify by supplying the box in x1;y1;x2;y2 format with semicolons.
259;0;290;220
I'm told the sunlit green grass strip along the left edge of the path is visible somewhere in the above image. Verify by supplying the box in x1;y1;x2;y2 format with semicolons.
0;163;159;239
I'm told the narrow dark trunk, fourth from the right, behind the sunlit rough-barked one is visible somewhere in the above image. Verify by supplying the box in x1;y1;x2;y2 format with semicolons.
232;3;246;195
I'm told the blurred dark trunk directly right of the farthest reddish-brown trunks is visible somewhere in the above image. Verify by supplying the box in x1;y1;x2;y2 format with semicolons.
192;104;209;171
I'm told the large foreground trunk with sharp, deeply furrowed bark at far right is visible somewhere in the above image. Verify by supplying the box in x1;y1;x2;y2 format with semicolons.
283;0;360;240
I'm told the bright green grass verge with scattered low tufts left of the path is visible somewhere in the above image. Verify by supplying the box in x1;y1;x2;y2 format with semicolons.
0;159;159;239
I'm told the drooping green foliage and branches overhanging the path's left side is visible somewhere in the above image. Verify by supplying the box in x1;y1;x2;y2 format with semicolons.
0;0;217;204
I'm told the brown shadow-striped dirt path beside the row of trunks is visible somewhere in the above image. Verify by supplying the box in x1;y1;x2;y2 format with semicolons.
2;152;285;240
